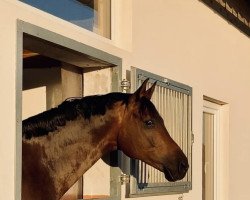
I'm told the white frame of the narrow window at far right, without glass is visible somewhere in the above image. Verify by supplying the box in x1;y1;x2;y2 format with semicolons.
203;101;229;200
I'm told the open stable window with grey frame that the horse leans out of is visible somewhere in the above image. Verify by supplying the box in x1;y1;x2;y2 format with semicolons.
16;21;121;200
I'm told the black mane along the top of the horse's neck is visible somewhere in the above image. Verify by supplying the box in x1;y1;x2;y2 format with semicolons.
22;93;129;139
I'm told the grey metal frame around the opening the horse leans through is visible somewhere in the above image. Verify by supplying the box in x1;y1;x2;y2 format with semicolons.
14;20;122;200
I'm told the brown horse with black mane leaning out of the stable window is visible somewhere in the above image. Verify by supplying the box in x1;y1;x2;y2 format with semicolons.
22;79;189;200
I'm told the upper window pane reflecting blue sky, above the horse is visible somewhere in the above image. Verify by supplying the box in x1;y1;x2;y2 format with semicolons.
20;0;111;39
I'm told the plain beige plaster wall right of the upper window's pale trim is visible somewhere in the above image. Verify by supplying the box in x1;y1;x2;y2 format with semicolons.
132;0;250;200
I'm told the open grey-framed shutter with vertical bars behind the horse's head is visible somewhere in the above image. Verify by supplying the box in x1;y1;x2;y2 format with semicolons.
127;68;192;197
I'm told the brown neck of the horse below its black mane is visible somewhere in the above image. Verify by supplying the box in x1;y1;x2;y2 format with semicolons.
23;106;121;199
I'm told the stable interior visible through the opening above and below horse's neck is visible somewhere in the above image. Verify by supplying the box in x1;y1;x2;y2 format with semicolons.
22;34;119;200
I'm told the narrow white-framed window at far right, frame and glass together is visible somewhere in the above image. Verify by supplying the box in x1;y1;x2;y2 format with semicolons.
202;100;229;200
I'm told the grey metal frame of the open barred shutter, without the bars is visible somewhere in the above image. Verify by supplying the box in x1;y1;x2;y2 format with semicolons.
124;67;193;197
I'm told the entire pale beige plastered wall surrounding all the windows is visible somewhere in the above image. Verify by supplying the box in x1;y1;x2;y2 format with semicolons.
0;0;250;200
